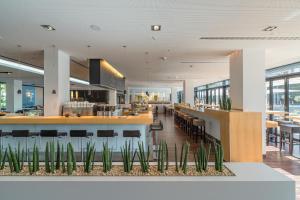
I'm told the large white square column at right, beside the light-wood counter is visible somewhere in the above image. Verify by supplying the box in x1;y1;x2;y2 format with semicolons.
230;49;266;154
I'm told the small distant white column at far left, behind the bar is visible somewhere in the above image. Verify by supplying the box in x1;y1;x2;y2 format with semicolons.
5;79;23;112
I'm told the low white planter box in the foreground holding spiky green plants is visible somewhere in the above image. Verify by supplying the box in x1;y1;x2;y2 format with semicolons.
0;163;295;200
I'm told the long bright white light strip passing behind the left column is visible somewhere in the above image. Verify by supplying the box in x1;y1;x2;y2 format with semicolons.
0;58;90;85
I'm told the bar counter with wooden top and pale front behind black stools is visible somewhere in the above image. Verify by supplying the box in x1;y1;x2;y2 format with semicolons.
0;112;153;152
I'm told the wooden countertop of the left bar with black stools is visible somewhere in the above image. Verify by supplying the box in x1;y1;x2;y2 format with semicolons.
0;112;153;125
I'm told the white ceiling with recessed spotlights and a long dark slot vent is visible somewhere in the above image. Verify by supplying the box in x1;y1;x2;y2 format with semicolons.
0;0;300;86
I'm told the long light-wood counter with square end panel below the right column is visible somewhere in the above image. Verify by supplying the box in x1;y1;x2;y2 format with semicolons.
176;106;262;162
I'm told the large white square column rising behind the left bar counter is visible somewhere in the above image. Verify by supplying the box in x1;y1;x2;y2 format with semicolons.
44;47;70;116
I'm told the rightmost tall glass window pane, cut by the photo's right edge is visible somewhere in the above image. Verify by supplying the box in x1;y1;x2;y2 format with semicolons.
289;77;300;115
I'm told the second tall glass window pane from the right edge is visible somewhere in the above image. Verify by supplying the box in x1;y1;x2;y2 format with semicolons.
272;79;285;111
